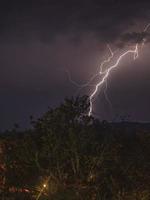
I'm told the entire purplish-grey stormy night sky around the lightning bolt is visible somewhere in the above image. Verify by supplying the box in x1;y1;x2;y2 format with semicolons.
0;0;150;129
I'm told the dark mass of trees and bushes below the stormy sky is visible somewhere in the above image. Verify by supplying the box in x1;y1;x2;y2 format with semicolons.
0;96;150;200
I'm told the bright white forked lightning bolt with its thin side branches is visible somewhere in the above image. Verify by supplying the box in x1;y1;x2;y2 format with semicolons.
67;23;150;116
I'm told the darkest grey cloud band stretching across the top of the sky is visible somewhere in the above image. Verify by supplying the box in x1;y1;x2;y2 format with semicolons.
0;0;150;42
